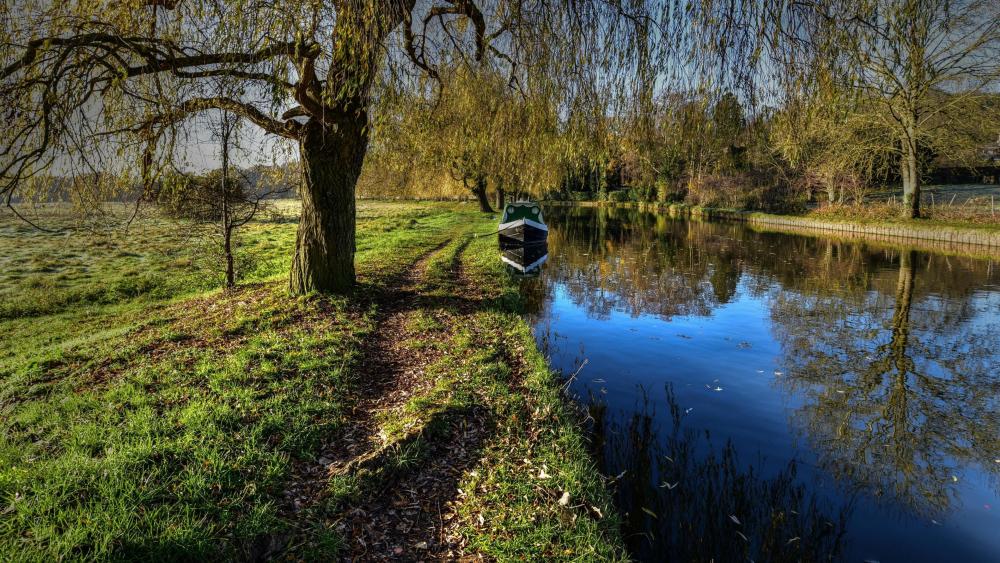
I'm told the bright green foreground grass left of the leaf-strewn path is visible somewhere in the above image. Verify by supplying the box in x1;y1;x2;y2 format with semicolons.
0;286;367;558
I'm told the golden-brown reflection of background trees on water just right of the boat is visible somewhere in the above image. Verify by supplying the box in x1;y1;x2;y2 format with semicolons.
527;209;752;318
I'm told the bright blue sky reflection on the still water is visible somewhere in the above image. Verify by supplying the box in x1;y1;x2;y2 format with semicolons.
528;210;1000;563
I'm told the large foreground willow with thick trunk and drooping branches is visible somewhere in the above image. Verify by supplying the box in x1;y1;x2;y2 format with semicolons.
0;0;684;293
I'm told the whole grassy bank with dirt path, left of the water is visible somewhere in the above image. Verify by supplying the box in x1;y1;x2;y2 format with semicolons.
0;204;621;560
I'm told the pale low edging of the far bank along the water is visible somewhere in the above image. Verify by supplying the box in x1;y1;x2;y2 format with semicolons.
545;201;1000;257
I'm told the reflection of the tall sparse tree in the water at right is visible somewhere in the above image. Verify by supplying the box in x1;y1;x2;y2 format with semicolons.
771;250;1000;513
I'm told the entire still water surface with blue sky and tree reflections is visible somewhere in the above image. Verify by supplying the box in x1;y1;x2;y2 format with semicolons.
522;208;1000;563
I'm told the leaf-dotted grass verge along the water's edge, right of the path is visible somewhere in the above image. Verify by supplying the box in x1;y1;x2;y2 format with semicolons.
455;239;624;561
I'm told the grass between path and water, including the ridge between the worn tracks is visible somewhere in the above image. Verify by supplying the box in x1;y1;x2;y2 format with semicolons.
354;232;624;561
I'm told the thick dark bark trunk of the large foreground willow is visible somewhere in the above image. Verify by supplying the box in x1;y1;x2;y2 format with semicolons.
289;119;368;294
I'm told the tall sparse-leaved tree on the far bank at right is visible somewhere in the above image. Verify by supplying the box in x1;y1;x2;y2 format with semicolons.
744;0;1000;218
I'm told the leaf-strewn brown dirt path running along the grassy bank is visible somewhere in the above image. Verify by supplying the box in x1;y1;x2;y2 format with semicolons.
278;232;491;561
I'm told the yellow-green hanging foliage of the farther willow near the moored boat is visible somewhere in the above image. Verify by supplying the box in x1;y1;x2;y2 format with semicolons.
366;66;574;212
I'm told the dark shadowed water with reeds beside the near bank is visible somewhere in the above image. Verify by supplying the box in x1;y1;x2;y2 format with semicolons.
591;386;849;562
